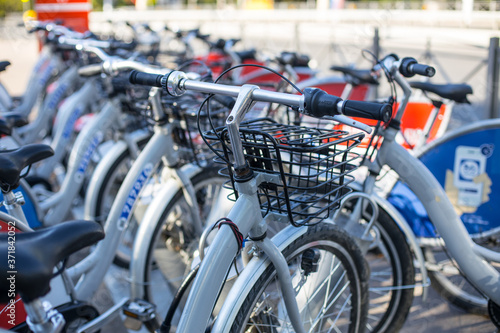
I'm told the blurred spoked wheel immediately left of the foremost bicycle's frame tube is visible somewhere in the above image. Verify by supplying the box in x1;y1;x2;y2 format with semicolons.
143;166;227;320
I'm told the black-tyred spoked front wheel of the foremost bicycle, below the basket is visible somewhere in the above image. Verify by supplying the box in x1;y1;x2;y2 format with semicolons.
230;223;369;333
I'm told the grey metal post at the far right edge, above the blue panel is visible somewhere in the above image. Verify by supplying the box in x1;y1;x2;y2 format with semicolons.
486;37;500;118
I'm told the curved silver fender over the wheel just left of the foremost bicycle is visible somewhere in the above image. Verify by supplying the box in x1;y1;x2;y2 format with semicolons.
130;164;203;299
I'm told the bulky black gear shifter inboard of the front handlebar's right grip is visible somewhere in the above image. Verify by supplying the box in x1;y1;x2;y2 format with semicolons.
303;88;342;118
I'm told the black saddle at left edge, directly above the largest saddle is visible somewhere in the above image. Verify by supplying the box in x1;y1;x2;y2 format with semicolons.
0;144;54;191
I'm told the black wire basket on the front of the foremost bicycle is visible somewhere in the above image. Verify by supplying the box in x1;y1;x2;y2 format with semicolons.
205;118;363;226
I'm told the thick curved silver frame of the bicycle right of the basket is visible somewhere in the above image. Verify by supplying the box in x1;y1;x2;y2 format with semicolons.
364;67;500;304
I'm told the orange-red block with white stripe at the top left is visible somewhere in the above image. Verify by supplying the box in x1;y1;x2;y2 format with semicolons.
35;0;92;32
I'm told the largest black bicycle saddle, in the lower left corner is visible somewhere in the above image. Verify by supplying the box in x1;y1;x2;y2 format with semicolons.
0;221;104;302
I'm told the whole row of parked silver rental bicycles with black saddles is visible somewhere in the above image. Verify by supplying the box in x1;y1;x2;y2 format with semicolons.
0;18;500;332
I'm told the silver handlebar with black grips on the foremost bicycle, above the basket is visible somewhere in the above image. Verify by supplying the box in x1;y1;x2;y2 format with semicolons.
129;71;392;121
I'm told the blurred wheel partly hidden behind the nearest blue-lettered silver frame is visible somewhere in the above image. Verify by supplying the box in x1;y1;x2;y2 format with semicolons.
93;137;149;269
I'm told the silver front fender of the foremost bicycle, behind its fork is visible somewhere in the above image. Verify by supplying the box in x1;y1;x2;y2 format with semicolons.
212;225;307;333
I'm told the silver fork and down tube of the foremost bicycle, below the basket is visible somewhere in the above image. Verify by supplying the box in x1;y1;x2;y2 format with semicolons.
177;174;305;333
